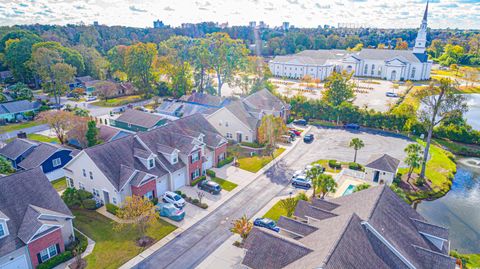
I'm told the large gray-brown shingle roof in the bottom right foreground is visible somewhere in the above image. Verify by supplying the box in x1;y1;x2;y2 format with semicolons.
242;185;455;269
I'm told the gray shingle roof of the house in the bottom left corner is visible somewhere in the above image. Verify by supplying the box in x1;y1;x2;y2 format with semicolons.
0;168;73;256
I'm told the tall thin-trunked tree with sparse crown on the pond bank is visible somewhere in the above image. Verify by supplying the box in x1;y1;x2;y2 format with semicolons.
417;78;468;178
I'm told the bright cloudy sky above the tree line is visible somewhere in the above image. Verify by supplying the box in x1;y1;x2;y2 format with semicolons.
0;0;480;29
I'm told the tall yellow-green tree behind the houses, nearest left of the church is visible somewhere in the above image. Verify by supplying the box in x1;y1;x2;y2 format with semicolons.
206;32;248;96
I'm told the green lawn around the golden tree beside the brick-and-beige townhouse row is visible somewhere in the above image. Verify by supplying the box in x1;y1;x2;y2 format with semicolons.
72;209;176;268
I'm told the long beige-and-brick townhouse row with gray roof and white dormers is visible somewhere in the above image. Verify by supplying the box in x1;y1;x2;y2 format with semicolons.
64;114;227;205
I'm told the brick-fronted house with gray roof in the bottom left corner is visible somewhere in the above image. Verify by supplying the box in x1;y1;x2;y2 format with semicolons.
0;167;74;269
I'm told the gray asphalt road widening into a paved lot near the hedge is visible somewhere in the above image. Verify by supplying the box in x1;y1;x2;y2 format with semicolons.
135;127;409;268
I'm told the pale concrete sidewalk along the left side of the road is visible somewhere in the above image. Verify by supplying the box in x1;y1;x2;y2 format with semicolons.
120;126;311;269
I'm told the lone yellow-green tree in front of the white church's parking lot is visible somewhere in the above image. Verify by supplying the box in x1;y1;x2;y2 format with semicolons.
323;72;355;106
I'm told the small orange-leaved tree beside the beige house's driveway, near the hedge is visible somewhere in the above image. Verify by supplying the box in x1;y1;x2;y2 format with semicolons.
258;115;287;157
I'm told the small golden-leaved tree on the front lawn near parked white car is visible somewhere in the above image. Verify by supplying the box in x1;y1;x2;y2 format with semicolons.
115;195;159;246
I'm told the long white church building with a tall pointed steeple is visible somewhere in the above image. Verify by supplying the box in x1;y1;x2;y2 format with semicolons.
269;2;433;81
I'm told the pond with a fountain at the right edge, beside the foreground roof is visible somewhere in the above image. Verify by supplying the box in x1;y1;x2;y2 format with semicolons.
417;158;480;253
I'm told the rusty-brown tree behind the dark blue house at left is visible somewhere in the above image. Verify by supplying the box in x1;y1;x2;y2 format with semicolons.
38;110;79;145
